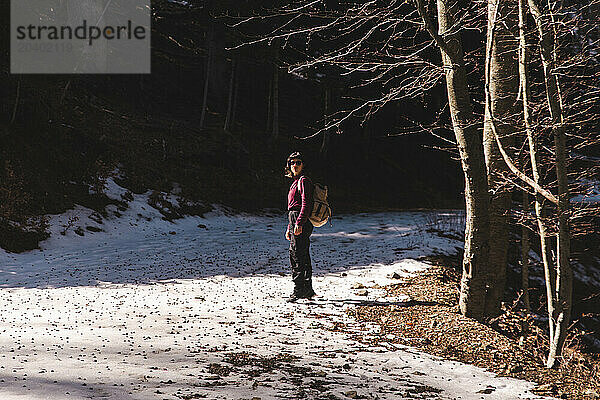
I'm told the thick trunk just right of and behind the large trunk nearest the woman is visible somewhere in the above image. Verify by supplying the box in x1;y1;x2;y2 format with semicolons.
483;0;519;317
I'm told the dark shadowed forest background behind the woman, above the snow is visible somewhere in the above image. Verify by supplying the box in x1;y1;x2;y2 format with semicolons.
0;0;463;248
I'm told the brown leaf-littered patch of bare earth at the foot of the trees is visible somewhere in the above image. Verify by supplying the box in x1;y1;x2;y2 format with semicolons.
348;266;600;400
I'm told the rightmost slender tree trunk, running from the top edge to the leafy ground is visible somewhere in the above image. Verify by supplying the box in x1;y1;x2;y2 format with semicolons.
528;0;573;368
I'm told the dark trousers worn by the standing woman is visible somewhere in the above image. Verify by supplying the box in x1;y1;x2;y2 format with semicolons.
288;210;313;296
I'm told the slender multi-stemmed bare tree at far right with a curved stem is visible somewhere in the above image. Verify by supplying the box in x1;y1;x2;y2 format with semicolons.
486;0;597;368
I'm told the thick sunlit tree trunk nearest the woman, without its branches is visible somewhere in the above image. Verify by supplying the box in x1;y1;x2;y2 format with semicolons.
437;0;489;320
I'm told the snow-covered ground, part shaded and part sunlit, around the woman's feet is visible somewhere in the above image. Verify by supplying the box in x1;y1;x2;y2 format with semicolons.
0;180;556;400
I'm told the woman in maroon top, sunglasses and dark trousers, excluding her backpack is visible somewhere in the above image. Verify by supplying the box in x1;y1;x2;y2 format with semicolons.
285;152;315;302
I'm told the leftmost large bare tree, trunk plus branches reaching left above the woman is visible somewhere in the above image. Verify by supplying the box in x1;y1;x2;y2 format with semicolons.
234;0;489;320
